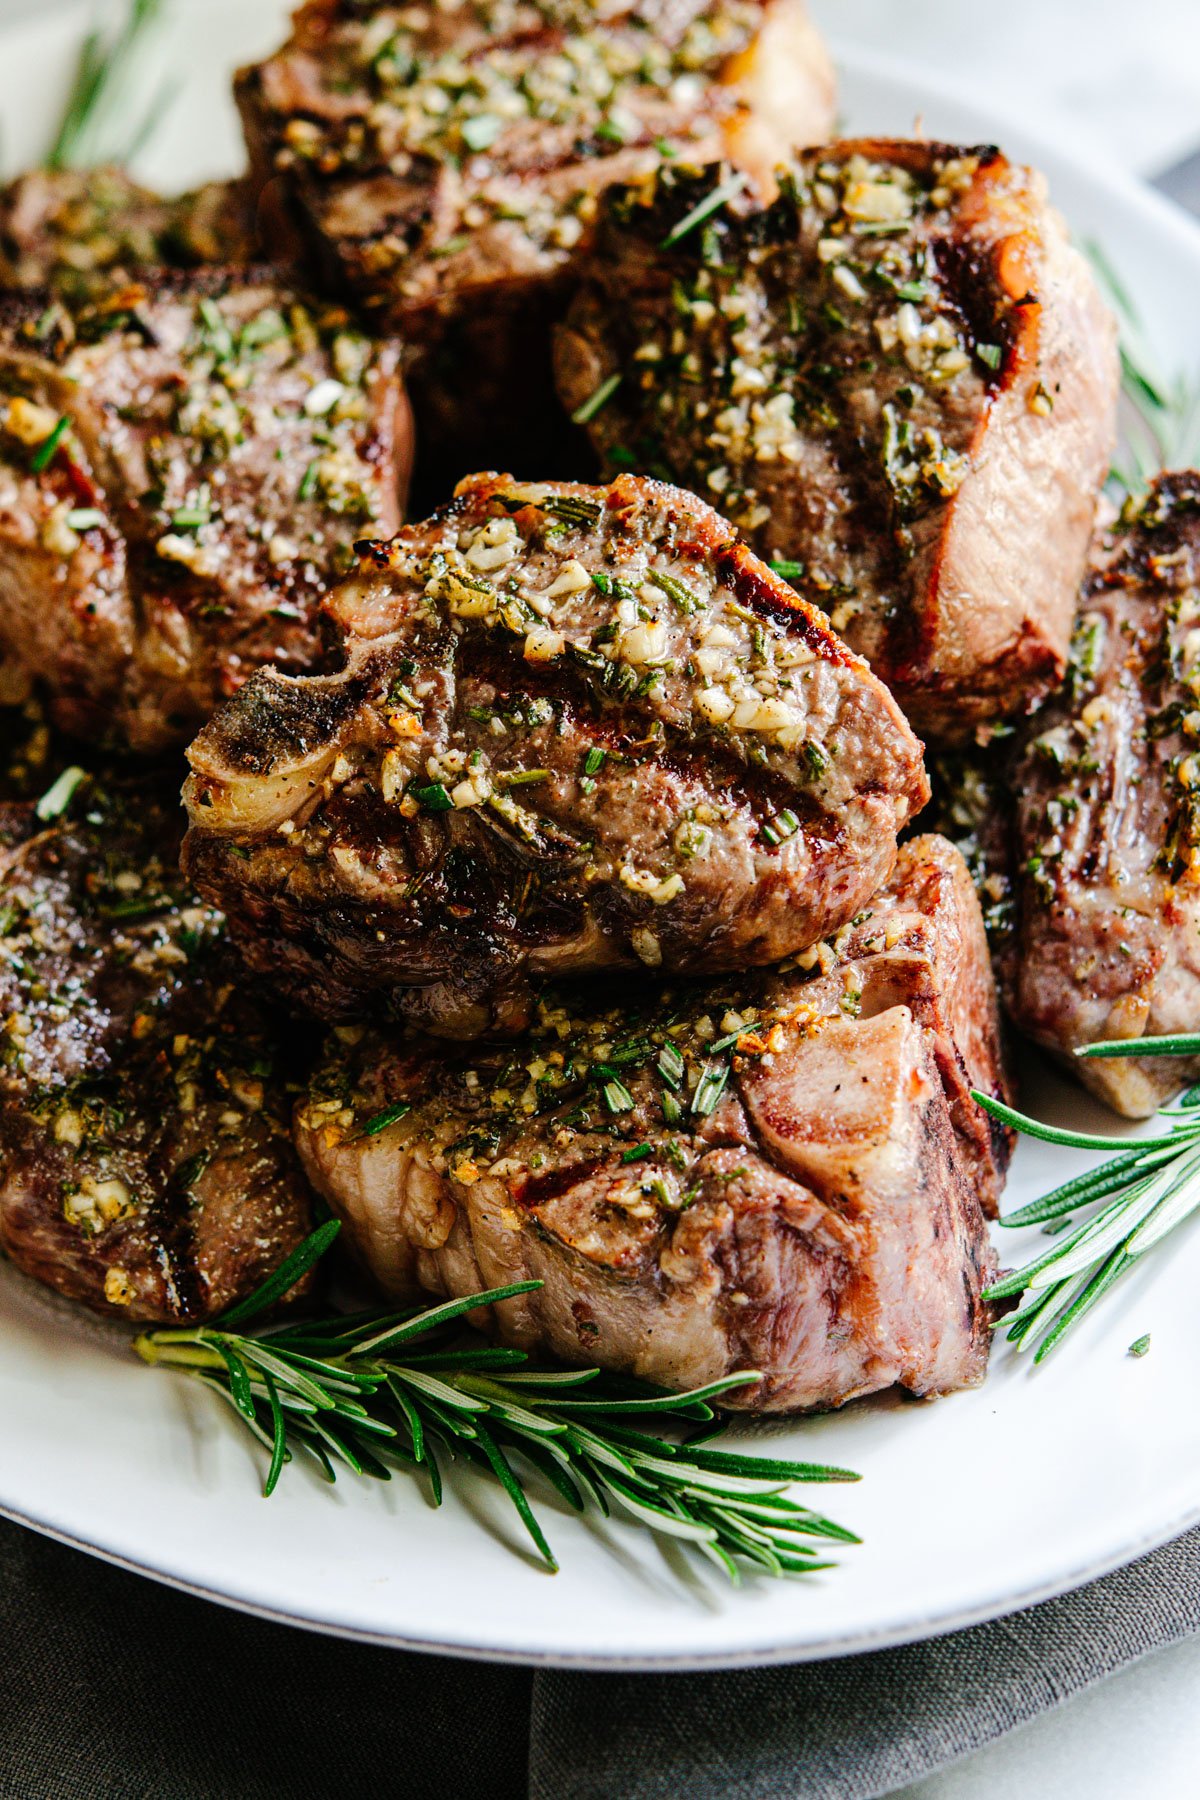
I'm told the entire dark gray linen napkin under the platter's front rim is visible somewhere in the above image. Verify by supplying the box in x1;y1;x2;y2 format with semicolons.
0;1521;1200;1800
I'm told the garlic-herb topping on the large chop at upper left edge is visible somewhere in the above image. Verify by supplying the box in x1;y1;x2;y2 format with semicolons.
0;286;378;580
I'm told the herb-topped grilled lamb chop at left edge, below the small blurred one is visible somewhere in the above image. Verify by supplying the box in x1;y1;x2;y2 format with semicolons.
0;272;408;751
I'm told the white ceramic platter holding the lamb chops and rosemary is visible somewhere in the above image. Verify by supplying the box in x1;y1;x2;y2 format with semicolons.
0;0;1200;1667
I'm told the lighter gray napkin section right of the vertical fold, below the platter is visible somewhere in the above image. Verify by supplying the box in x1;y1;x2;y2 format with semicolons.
529;1530;1200;1800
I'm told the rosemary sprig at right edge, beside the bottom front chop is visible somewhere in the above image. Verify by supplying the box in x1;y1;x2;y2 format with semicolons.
973;1072;1200;1363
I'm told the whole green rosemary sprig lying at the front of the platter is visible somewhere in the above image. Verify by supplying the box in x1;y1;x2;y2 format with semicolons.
135;1220;858;1582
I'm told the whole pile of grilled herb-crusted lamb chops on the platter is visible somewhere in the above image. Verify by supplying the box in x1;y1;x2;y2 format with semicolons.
0;0;1173;1411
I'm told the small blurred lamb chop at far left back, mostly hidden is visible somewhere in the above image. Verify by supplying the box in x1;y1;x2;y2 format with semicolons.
0;167;255;302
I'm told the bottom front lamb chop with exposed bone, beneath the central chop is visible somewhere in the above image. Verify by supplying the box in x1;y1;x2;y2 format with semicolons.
297;837;1007;1411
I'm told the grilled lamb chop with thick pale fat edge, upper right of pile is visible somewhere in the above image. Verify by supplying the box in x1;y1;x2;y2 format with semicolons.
556;140;1117;740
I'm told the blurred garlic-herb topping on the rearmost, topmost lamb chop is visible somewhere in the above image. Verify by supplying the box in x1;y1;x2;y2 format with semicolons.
264;0;763;299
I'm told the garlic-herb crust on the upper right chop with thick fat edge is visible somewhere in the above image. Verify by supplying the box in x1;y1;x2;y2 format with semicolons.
570;146;1052;655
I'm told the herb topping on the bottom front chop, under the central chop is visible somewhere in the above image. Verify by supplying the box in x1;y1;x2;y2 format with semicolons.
299;909;892;1219
